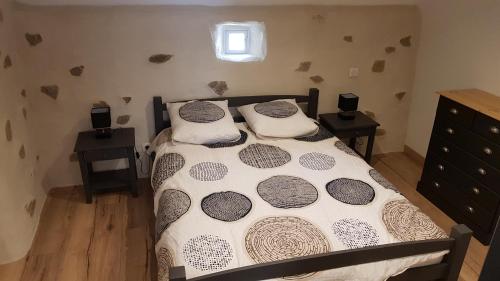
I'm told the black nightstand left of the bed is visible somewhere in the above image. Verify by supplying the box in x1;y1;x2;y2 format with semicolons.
75;128;137;203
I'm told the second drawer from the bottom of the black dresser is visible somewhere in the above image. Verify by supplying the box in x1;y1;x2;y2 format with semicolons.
424;153;500;210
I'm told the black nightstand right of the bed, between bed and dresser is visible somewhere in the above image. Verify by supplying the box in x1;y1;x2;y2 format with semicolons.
319;111;380;163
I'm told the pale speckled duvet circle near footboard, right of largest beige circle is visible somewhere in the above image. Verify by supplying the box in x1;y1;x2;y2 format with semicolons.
332;219;379;249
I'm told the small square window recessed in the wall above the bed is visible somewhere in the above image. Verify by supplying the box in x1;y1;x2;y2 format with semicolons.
212;22;266;62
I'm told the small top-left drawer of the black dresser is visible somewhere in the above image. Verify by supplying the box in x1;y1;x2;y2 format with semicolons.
436;97;476;128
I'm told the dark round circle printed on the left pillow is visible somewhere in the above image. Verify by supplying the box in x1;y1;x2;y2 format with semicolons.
179;101;226;123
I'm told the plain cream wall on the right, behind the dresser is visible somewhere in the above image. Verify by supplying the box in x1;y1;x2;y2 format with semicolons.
406;0;500;156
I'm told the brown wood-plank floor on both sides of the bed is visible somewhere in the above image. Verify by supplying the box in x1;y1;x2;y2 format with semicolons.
0;153;487;281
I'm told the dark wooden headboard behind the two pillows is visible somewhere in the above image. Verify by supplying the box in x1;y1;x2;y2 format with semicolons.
153;88;319;135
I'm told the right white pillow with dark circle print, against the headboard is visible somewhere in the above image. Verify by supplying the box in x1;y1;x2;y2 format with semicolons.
238;99;318;138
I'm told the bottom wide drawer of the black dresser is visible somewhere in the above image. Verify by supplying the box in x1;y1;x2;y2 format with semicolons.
421;176;495;231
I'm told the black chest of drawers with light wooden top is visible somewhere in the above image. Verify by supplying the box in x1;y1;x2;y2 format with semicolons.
417;89;500;244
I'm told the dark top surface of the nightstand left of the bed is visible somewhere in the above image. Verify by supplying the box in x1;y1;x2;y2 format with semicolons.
74;128;135;152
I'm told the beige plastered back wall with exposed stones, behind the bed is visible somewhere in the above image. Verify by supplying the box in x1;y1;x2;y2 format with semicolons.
16;6;419;186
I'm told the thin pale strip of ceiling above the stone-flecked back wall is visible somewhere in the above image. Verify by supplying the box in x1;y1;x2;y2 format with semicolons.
17;0;418;6
